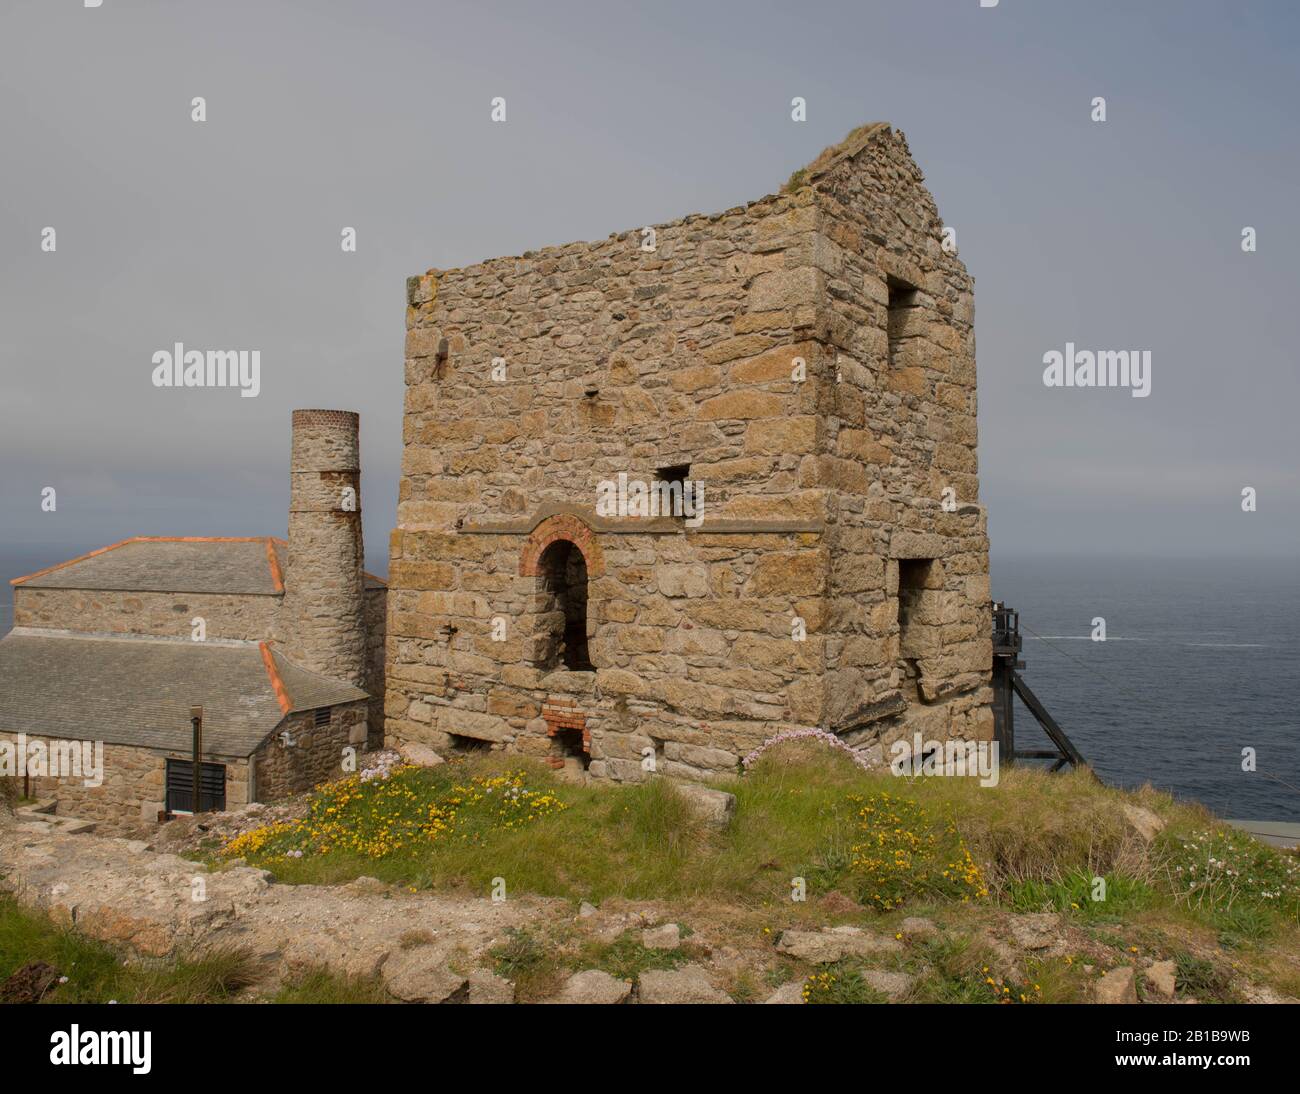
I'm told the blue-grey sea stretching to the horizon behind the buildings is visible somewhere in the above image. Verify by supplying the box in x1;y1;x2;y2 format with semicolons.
0;544;1300;821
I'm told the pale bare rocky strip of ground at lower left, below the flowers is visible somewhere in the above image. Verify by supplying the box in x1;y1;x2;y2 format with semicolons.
0;824;559;994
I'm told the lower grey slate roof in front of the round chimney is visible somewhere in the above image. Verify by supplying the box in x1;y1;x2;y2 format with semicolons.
0;628;367;756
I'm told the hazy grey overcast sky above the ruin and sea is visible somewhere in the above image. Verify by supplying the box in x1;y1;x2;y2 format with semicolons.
0;0;1300;577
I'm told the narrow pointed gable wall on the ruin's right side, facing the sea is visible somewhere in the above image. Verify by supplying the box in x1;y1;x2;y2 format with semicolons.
814;131;992;741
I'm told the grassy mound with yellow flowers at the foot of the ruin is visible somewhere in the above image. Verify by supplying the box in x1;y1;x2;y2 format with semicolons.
209;743;1300;919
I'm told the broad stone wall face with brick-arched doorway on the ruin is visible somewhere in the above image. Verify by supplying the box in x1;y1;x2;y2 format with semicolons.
386;192;829;778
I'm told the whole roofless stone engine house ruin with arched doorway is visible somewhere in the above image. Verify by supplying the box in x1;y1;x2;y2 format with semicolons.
385;123;992;780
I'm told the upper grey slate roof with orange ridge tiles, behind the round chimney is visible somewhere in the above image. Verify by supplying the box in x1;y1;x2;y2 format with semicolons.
10;535;384;595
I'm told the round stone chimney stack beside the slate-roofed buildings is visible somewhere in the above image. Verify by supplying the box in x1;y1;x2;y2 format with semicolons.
276;411;365;687
